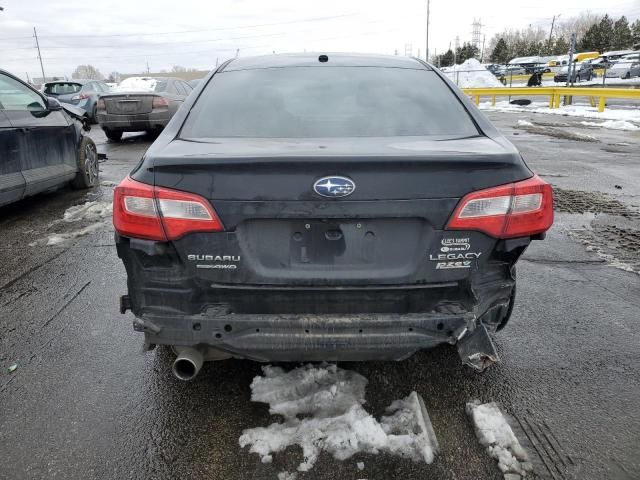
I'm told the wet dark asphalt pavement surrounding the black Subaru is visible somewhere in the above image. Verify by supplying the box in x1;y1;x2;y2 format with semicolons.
0;117;640;480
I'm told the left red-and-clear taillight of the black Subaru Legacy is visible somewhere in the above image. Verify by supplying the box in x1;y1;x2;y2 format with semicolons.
113;177;224;241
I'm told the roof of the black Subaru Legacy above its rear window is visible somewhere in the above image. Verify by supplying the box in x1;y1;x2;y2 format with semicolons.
221;52;431;72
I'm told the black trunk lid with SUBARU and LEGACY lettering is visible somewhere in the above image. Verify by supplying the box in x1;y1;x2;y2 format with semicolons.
144;136;531;287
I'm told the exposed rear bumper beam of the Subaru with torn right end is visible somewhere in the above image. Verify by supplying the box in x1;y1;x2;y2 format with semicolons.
134;309;497;364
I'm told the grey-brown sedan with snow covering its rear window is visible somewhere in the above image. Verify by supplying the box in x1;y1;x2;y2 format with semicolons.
97;77;193;141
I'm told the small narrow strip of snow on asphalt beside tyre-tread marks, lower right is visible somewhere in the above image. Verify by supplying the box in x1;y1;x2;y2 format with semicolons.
466;401;533;476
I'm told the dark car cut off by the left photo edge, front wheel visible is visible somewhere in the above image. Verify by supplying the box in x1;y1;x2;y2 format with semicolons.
0;70;98;206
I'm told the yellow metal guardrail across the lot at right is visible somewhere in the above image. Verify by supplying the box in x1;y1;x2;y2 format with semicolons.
462;87;640;112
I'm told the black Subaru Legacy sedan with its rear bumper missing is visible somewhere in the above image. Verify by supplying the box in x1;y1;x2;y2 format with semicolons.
113;54;553;380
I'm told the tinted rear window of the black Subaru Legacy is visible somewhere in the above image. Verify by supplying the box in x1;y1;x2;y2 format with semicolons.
181;67;478;139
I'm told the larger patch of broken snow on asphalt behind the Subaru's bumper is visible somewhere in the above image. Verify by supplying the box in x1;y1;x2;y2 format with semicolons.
239;365;438;472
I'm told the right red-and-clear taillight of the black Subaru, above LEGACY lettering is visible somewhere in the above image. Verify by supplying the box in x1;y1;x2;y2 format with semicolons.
447;175;553;238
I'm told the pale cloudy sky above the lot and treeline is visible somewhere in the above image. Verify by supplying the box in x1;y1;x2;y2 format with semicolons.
0;0;640;78
